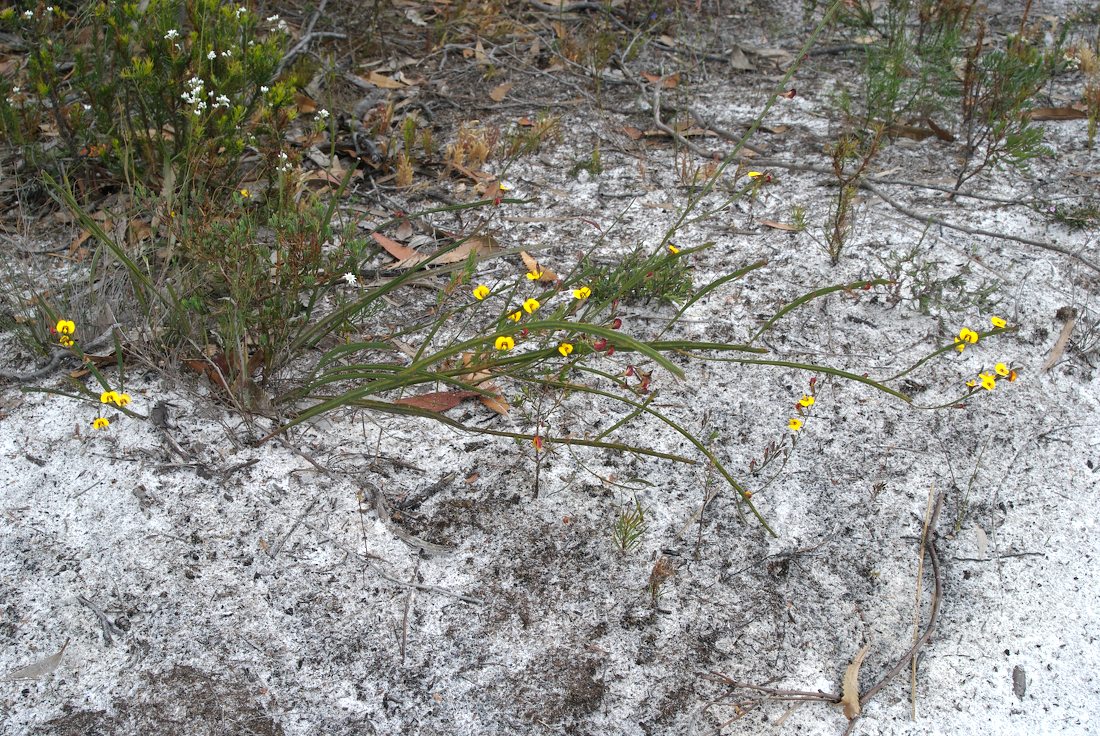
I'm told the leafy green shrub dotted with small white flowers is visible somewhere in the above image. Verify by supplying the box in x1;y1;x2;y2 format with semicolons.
0;0;294;196
